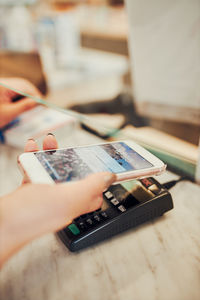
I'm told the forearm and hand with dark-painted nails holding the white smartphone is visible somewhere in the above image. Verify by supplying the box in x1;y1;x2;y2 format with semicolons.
0;136;116;265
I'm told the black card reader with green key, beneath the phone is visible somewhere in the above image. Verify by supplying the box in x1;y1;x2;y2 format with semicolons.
58;177;173;251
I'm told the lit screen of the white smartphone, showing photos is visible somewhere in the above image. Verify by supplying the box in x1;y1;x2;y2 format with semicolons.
34;142;153;182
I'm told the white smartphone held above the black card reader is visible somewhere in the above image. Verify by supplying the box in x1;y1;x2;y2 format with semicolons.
18;141;166;183
